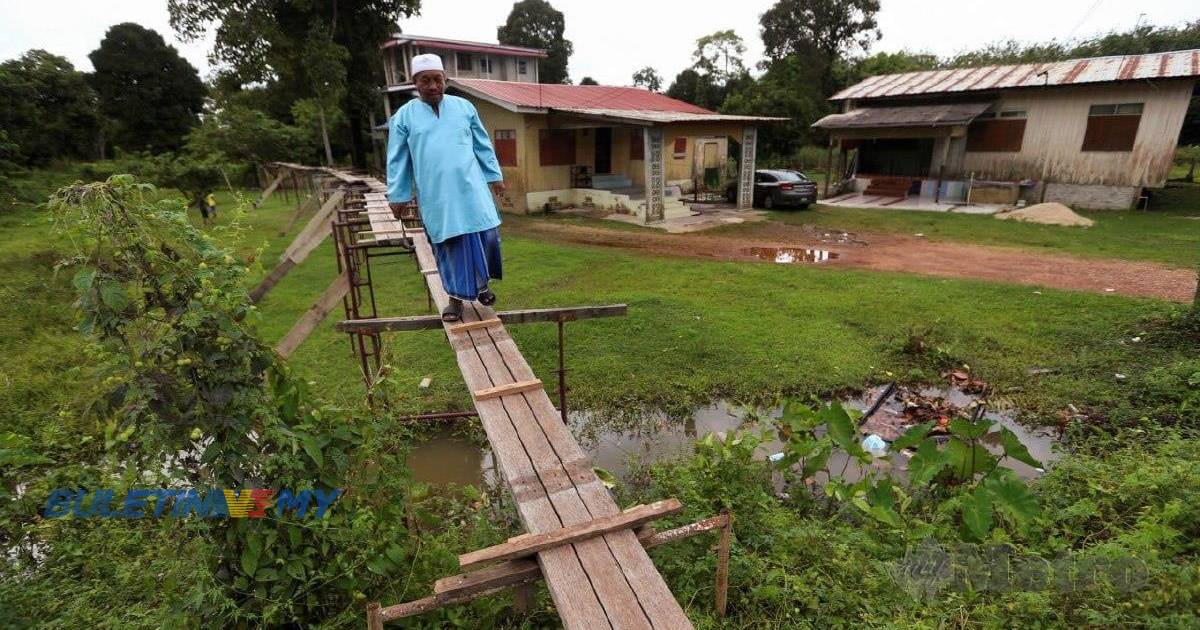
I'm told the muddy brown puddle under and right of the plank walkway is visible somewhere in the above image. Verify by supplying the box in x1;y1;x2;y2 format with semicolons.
408;386;1058;486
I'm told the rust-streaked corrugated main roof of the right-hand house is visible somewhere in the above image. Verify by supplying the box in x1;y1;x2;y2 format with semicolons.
829;49;1200;101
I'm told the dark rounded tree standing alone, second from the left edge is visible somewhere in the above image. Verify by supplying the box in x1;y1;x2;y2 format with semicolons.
88;22;205;152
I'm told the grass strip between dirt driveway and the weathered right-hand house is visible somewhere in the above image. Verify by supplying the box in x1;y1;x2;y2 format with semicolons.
715;186;1200;266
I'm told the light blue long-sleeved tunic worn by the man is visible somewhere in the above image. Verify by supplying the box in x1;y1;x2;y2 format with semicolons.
388;95;504;244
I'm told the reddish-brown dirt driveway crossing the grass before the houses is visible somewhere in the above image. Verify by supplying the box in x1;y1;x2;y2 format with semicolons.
509;220;1196;302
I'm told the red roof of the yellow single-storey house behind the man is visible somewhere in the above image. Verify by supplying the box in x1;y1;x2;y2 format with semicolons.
450;79;714;114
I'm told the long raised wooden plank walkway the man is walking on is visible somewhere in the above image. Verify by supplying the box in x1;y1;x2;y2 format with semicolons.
352;178;691;629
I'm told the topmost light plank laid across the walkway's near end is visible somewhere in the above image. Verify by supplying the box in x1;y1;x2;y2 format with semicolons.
458;499;683;570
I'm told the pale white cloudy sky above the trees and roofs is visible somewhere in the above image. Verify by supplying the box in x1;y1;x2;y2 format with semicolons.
0;0;1200;85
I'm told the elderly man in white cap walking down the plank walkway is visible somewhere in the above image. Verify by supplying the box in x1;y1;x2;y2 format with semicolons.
388;54;504;322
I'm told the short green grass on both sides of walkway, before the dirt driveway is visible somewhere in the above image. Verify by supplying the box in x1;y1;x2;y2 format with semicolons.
0;166;1181;424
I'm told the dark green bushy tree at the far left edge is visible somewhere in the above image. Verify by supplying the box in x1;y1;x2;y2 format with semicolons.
0;50;100;166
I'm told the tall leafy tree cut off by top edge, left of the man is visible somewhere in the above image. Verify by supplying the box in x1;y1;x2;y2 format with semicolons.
167;0;420;168
